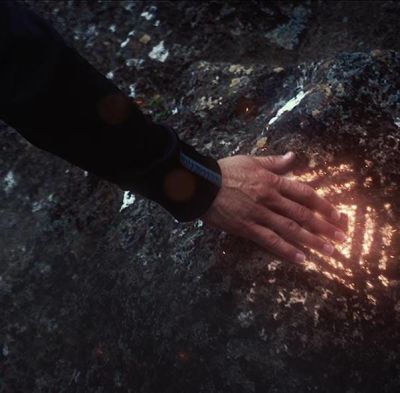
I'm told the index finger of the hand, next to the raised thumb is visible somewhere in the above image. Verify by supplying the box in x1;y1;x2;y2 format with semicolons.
278;177;340;223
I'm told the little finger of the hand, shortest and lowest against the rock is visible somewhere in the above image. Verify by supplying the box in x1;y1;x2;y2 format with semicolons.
245;224;306;262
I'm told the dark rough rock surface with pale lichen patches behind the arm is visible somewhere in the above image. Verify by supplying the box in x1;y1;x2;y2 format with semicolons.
0;1;400;393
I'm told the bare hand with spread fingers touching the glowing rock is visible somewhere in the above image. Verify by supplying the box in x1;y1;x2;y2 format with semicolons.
200;153;345;262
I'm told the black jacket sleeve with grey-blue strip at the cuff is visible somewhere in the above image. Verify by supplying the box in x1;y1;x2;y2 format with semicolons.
0;0;221;222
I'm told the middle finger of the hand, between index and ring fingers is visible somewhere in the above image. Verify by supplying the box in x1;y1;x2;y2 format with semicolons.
270;196;346;242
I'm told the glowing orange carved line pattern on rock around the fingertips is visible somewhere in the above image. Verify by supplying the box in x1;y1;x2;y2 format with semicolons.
294;159;396;290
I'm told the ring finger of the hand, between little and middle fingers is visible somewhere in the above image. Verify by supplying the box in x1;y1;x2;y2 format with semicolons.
253;207;335;256
